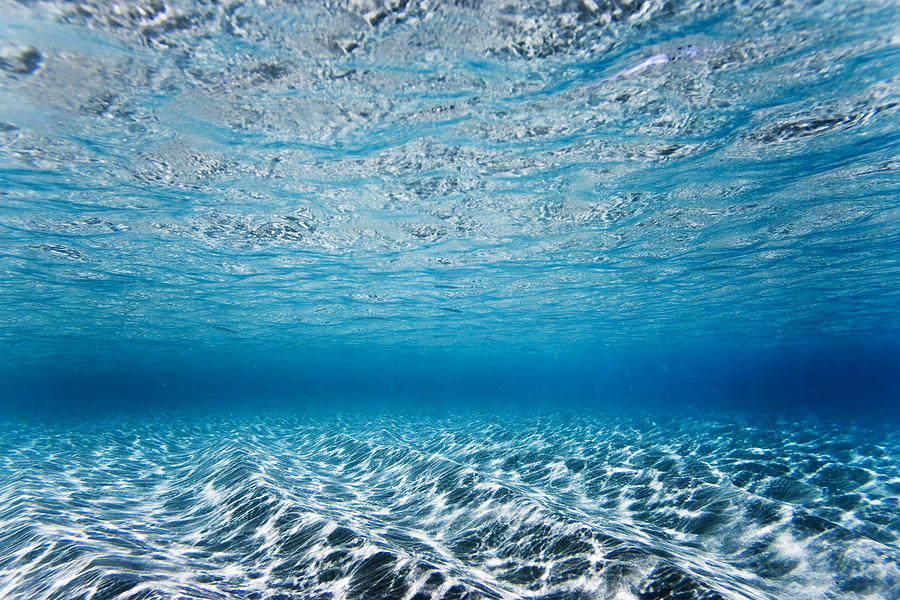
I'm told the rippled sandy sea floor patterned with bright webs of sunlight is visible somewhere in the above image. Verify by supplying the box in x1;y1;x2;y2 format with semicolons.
0;411;900;600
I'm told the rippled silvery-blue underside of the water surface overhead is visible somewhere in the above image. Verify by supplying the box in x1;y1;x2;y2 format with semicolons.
0;0;900;360
